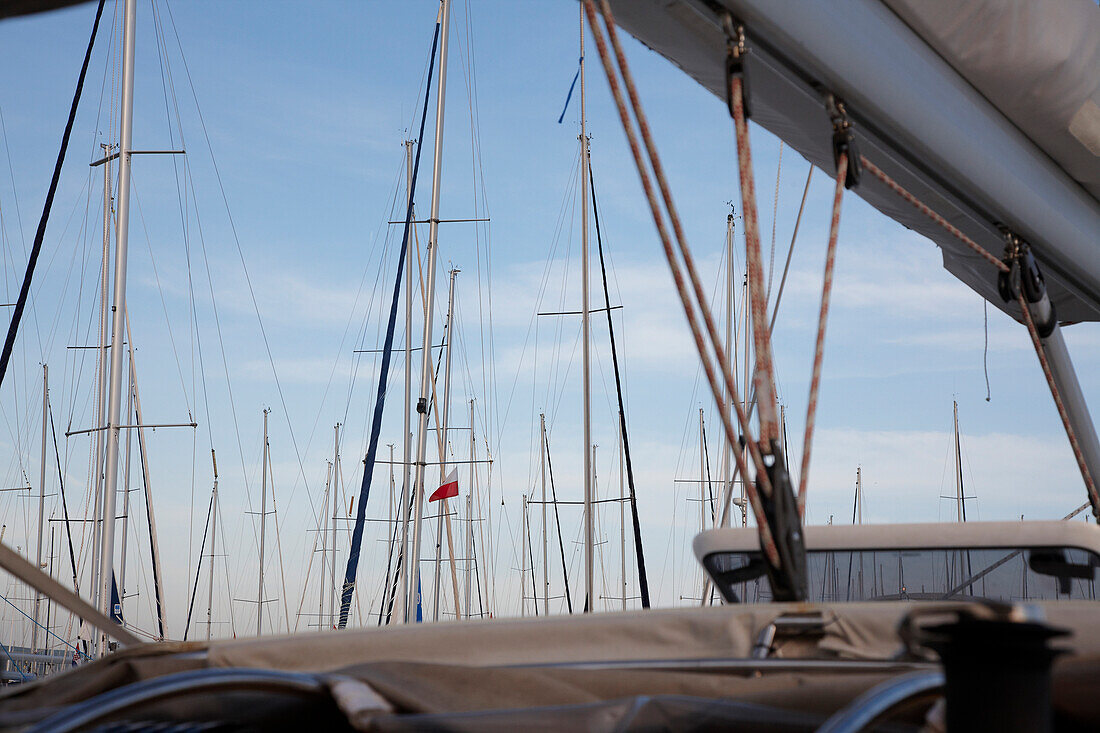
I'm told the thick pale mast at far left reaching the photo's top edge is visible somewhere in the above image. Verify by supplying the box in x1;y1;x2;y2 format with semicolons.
99;0;138;655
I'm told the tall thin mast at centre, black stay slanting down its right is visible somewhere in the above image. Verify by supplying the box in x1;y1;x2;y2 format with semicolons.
581;0;596;612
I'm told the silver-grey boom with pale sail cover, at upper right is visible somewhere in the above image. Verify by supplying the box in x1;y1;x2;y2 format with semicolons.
612;0;1100;321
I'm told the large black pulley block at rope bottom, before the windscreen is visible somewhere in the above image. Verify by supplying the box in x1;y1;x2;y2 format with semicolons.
758;440;810;602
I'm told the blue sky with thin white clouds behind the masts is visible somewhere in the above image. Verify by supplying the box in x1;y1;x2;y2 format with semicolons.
0;0;1100;636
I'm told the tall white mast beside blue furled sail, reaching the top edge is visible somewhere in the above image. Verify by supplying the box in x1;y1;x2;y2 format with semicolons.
406;0;451;619
